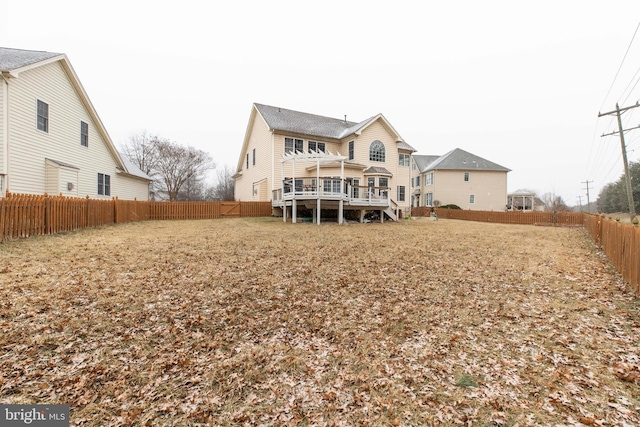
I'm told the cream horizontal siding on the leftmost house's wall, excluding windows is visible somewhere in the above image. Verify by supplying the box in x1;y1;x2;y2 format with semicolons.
9;62;148;200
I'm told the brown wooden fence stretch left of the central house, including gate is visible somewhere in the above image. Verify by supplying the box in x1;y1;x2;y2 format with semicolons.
0;193;271;241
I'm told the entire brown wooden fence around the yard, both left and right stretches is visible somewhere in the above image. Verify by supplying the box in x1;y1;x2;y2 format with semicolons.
0;194;640;292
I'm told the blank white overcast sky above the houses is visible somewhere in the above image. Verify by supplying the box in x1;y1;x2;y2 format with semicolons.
0;0;640;205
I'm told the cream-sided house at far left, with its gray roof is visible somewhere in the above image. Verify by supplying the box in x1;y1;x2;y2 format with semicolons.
0;48;151;200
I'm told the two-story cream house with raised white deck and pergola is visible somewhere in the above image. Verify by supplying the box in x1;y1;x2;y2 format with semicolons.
233;104;415;223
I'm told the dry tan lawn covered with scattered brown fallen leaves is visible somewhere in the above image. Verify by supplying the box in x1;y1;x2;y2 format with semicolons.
0;218;640;426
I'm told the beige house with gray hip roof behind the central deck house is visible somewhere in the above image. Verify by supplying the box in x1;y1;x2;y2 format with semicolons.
412;148;510;211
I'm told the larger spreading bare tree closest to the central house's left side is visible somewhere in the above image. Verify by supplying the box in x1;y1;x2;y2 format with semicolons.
154;139;215;201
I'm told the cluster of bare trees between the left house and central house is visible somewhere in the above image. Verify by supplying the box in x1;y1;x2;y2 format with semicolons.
120;131;234;201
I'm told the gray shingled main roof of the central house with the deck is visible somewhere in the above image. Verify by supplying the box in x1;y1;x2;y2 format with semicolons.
254;104;380;139
